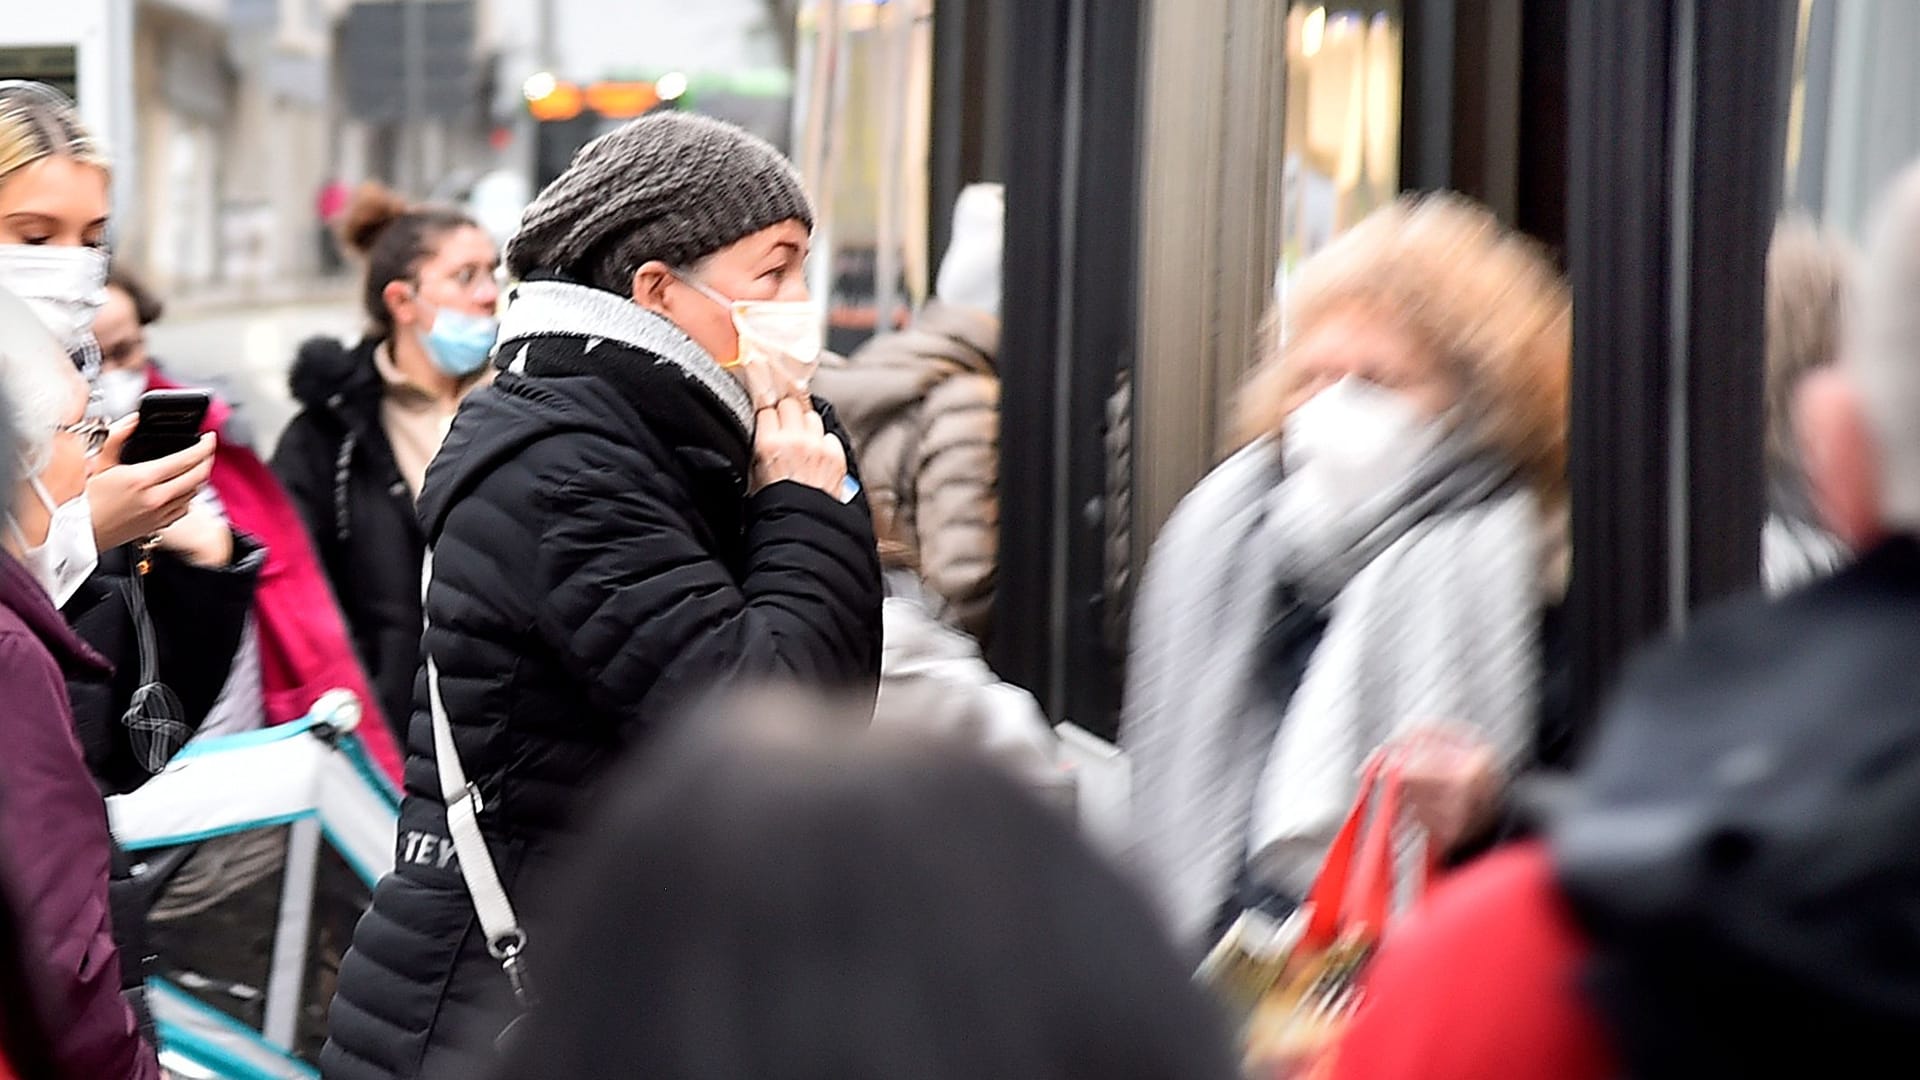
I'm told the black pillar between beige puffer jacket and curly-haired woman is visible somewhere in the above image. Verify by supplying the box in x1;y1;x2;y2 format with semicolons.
989;0;1142;734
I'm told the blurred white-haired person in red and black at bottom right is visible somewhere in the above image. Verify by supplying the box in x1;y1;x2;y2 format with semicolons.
1332;159;1920;1080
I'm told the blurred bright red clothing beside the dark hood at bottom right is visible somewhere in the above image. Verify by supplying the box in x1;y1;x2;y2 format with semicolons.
1325;844;1619;1080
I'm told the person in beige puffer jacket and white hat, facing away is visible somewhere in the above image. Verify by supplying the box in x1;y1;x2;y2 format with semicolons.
814;184;1006;642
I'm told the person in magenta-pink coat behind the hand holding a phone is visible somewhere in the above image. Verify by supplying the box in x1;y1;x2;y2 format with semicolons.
94;261;399;764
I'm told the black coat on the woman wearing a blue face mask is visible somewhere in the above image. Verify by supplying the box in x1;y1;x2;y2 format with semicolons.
273;338;426;742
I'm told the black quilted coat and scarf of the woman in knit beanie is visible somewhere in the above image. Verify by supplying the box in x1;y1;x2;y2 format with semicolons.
321;286;881;1080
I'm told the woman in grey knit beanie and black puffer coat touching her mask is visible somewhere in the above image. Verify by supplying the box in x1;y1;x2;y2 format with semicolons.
321;111;881;1080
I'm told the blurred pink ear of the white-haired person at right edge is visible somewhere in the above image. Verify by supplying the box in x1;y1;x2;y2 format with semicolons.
1793;365;1885;552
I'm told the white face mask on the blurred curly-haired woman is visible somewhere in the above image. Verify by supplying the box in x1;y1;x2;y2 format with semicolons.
1281;377;1442;523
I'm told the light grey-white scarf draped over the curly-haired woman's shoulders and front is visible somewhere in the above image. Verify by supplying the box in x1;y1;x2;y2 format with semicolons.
1121;430;1544;942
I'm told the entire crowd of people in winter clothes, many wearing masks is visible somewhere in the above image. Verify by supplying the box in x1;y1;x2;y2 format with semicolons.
0;69;1920;1080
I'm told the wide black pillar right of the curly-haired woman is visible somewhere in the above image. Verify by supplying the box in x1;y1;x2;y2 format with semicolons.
1567;0;1793;730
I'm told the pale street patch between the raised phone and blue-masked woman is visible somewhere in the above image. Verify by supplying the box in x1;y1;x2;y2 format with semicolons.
146;288;363;457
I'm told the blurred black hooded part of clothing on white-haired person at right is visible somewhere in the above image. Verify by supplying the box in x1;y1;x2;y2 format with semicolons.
1549;536;1920;1080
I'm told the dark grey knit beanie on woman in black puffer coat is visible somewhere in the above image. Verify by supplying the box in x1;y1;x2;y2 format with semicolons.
507;111;814;294
